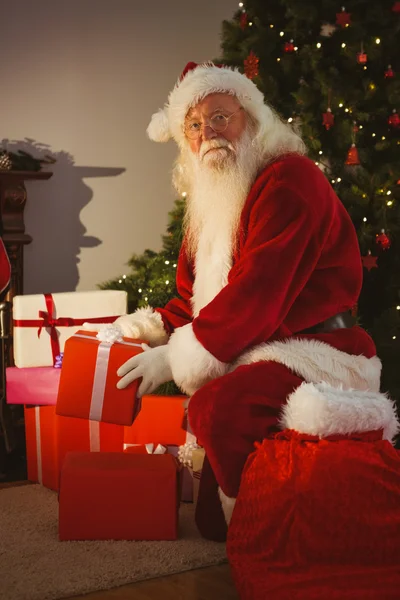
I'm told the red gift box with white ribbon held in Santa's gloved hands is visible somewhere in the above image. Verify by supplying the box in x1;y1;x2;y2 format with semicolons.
57;331;143;425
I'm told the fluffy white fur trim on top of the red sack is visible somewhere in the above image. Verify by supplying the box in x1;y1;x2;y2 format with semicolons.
281;383;400;441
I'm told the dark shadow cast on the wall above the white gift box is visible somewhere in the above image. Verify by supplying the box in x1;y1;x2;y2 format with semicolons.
1;139;125;294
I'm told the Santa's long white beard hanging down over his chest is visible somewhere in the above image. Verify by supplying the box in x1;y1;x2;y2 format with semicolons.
179;130;260;317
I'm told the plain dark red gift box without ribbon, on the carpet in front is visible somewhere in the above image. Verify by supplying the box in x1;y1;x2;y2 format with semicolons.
59;452;178;540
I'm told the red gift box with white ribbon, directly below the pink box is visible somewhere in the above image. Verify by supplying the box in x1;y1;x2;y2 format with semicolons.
24;406;58;490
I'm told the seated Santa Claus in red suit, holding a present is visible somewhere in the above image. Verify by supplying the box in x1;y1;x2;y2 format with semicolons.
83;63;397;539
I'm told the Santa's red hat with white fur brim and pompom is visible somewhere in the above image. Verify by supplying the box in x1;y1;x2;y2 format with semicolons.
147;62;272;143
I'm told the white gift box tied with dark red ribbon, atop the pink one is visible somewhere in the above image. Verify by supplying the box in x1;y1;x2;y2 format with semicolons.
13;290;127;367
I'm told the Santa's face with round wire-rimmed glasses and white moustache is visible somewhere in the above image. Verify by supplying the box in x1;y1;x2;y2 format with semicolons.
184;94;247;170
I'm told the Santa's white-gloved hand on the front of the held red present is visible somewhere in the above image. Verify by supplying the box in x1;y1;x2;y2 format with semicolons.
117;344;172;398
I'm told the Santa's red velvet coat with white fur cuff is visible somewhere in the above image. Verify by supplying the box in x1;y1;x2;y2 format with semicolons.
157;155;379;394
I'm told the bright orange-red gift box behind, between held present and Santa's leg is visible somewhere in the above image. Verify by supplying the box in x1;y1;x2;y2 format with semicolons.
124;395;191;446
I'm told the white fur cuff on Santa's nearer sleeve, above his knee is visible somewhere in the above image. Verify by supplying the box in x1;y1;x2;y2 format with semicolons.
168;323;228;395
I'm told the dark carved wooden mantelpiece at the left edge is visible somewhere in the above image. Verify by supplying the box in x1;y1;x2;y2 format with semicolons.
0;171;52;458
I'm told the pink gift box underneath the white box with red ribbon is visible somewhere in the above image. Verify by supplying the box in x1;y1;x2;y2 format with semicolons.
6;367;61;406
